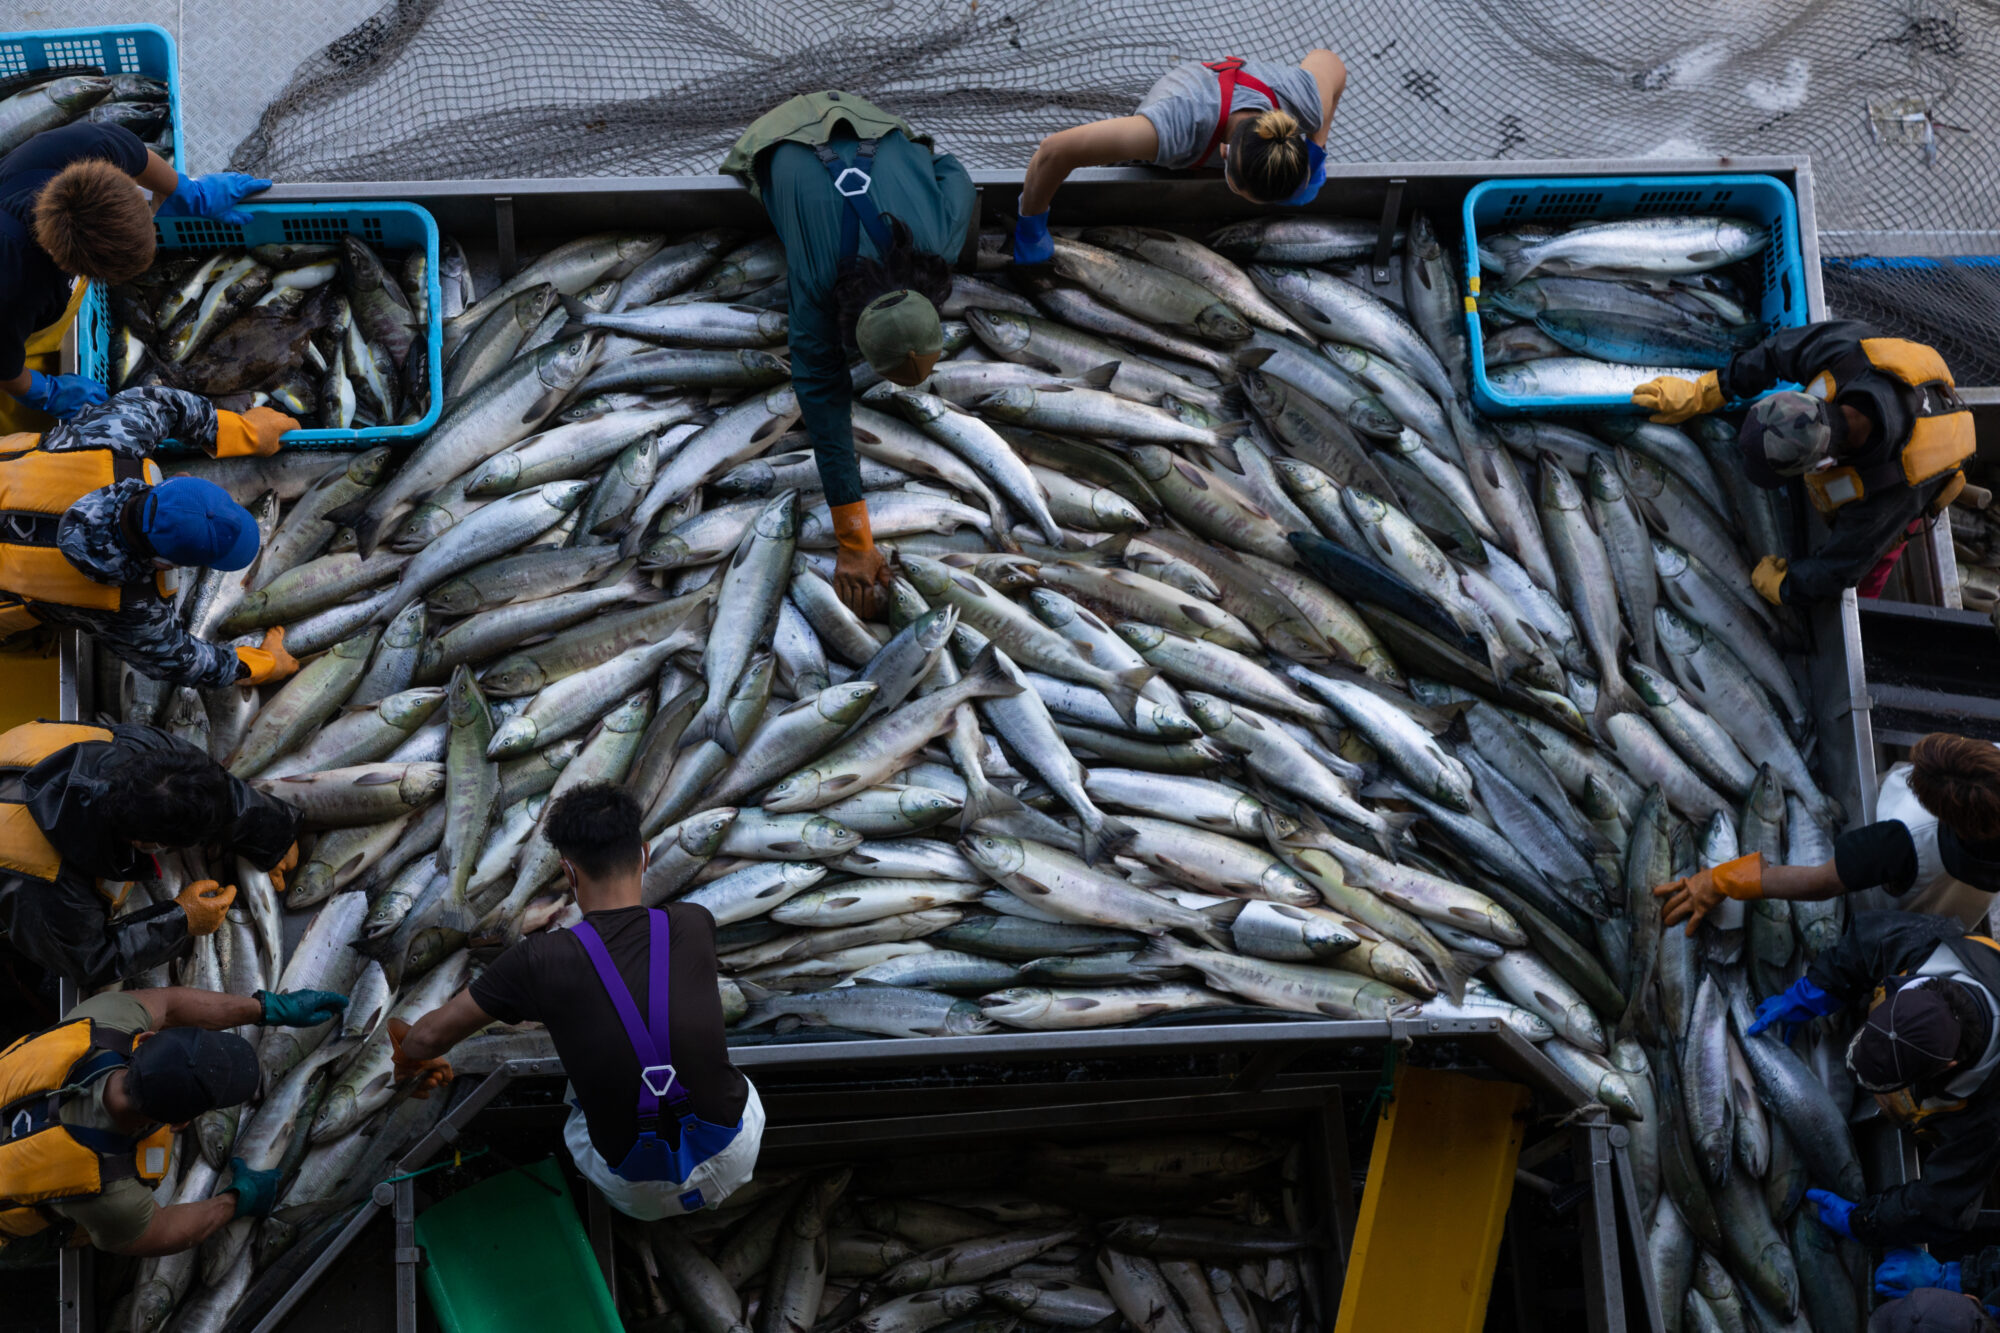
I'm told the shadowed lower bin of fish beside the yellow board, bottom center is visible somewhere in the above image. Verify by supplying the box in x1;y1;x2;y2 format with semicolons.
616;1133;1334;1333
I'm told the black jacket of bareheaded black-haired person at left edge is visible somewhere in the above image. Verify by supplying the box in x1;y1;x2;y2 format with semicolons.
0;727;298;987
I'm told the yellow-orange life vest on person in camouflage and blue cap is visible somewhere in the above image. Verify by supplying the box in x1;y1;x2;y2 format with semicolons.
0;434;168;636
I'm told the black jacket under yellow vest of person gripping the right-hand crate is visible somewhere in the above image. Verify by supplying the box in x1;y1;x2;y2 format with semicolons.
1718;320;1952;602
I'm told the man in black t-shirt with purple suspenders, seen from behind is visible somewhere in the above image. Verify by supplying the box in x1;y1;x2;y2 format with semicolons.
390;783;764;1221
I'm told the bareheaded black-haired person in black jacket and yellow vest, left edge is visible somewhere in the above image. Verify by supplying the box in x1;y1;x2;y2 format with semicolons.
0;723;298;989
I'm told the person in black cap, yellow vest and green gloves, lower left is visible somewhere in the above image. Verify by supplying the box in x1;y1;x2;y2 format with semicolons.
0;987;348;1269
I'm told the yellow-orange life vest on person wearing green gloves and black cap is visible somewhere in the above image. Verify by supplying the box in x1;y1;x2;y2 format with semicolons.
0;1019;174;1247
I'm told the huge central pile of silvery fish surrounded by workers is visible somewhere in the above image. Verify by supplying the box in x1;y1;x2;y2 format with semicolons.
106;202;1856;1329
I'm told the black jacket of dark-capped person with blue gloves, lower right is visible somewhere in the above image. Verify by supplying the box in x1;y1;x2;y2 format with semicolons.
1806;913;2000;1245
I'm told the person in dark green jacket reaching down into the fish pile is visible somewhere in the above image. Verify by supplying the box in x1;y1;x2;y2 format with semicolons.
722;92;978;620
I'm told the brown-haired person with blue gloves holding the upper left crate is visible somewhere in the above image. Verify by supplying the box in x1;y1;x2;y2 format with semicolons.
0;122;270;434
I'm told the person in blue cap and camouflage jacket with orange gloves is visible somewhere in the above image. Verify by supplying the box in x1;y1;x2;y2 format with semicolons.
0;386;298;691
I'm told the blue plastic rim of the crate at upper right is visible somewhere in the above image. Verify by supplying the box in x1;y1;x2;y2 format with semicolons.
1464;174;1806;416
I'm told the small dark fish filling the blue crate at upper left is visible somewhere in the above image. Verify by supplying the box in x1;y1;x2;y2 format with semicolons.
106;236;432;430
